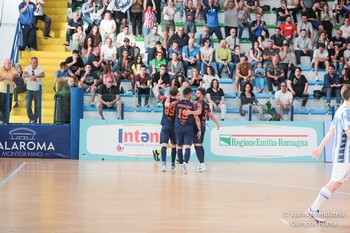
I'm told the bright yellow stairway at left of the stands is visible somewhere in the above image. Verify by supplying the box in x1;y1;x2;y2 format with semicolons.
14;0;71;124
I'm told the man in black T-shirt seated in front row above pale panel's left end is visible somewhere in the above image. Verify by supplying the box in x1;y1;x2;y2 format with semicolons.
97;78;122;120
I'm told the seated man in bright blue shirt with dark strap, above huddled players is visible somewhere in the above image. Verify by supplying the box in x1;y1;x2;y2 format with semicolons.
182;38;201;77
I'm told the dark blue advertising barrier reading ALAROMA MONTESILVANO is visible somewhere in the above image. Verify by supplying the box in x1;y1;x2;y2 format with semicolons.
0;124;70;158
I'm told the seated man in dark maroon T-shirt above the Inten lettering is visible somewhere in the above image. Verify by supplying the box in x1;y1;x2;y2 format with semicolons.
135;65;152;107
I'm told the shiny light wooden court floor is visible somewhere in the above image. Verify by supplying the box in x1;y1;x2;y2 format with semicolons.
0;159;350;233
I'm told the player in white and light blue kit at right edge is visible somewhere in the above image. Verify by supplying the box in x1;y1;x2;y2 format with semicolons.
307;85;350;223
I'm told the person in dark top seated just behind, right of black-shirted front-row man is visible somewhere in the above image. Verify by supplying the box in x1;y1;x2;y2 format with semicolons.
116;50;135;94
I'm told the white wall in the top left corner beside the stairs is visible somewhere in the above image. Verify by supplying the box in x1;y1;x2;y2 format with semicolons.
0;0;22;63
